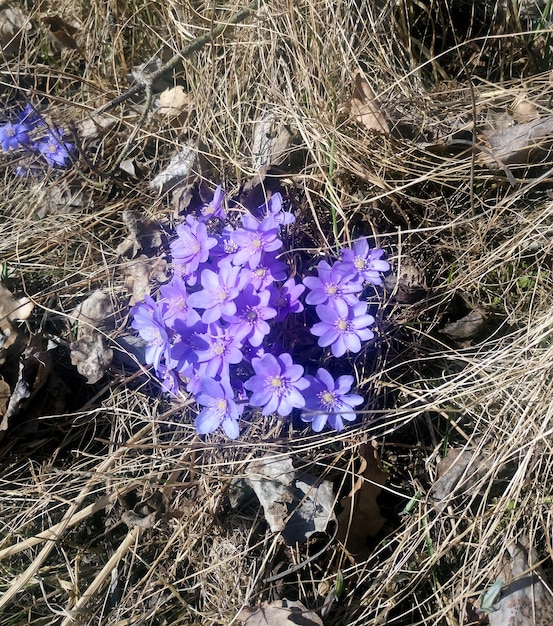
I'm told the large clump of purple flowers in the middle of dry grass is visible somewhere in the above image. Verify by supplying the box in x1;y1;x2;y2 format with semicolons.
131;187;389;438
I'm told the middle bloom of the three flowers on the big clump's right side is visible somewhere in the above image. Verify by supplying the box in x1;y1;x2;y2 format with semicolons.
303;261;363;315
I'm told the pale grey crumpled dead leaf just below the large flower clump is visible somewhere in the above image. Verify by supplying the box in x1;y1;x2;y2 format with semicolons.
246;457;335;545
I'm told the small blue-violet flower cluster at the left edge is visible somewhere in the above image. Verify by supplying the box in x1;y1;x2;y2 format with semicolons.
0;104;73;173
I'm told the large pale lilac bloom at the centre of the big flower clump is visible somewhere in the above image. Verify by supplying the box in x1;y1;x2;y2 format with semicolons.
188;262;249;324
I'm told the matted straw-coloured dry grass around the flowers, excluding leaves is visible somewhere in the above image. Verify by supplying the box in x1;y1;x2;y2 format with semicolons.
0;0;553;626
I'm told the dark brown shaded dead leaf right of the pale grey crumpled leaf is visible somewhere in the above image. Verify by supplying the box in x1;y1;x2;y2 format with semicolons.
337;442;388;561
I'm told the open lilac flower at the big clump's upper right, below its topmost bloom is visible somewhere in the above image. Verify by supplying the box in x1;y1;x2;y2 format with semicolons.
231;213;282;269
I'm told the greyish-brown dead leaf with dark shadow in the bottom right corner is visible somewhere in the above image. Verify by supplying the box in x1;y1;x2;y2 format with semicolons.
487;544;553;626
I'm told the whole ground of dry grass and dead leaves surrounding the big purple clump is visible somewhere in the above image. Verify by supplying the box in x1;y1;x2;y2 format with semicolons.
0;0;553;626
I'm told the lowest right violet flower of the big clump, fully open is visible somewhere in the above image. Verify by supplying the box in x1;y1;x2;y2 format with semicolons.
301;367;363;433
